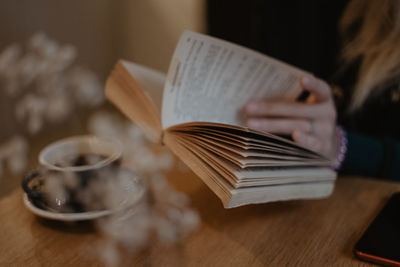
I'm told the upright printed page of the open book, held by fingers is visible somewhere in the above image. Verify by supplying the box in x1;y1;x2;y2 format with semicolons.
162;31;307;129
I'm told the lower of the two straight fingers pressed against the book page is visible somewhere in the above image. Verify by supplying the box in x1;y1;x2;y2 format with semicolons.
247;118;312;135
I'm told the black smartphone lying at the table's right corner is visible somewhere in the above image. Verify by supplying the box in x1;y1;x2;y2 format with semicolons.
354;192;400;266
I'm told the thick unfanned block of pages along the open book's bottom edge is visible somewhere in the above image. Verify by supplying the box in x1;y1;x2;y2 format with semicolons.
164;133;335;208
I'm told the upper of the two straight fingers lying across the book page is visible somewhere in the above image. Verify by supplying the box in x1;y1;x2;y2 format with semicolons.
244;101;321;118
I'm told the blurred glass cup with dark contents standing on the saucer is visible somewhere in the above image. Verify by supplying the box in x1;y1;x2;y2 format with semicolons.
22;135;122;213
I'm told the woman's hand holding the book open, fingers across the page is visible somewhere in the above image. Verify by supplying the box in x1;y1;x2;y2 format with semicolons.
243;76;336;158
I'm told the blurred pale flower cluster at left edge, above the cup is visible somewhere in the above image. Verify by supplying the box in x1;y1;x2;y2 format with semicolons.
0;33;104;177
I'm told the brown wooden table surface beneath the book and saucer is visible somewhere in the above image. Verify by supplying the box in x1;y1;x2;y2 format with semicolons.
0;169;400;267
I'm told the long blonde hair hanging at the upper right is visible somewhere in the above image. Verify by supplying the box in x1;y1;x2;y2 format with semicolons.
339;0;400;111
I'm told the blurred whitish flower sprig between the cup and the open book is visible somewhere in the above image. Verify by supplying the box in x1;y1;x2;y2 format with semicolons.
88;111;200;265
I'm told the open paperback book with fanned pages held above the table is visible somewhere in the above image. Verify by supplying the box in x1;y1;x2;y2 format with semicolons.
106;31;336;208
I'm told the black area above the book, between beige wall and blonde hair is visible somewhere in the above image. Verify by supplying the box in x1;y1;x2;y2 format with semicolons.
207;0;348;81
